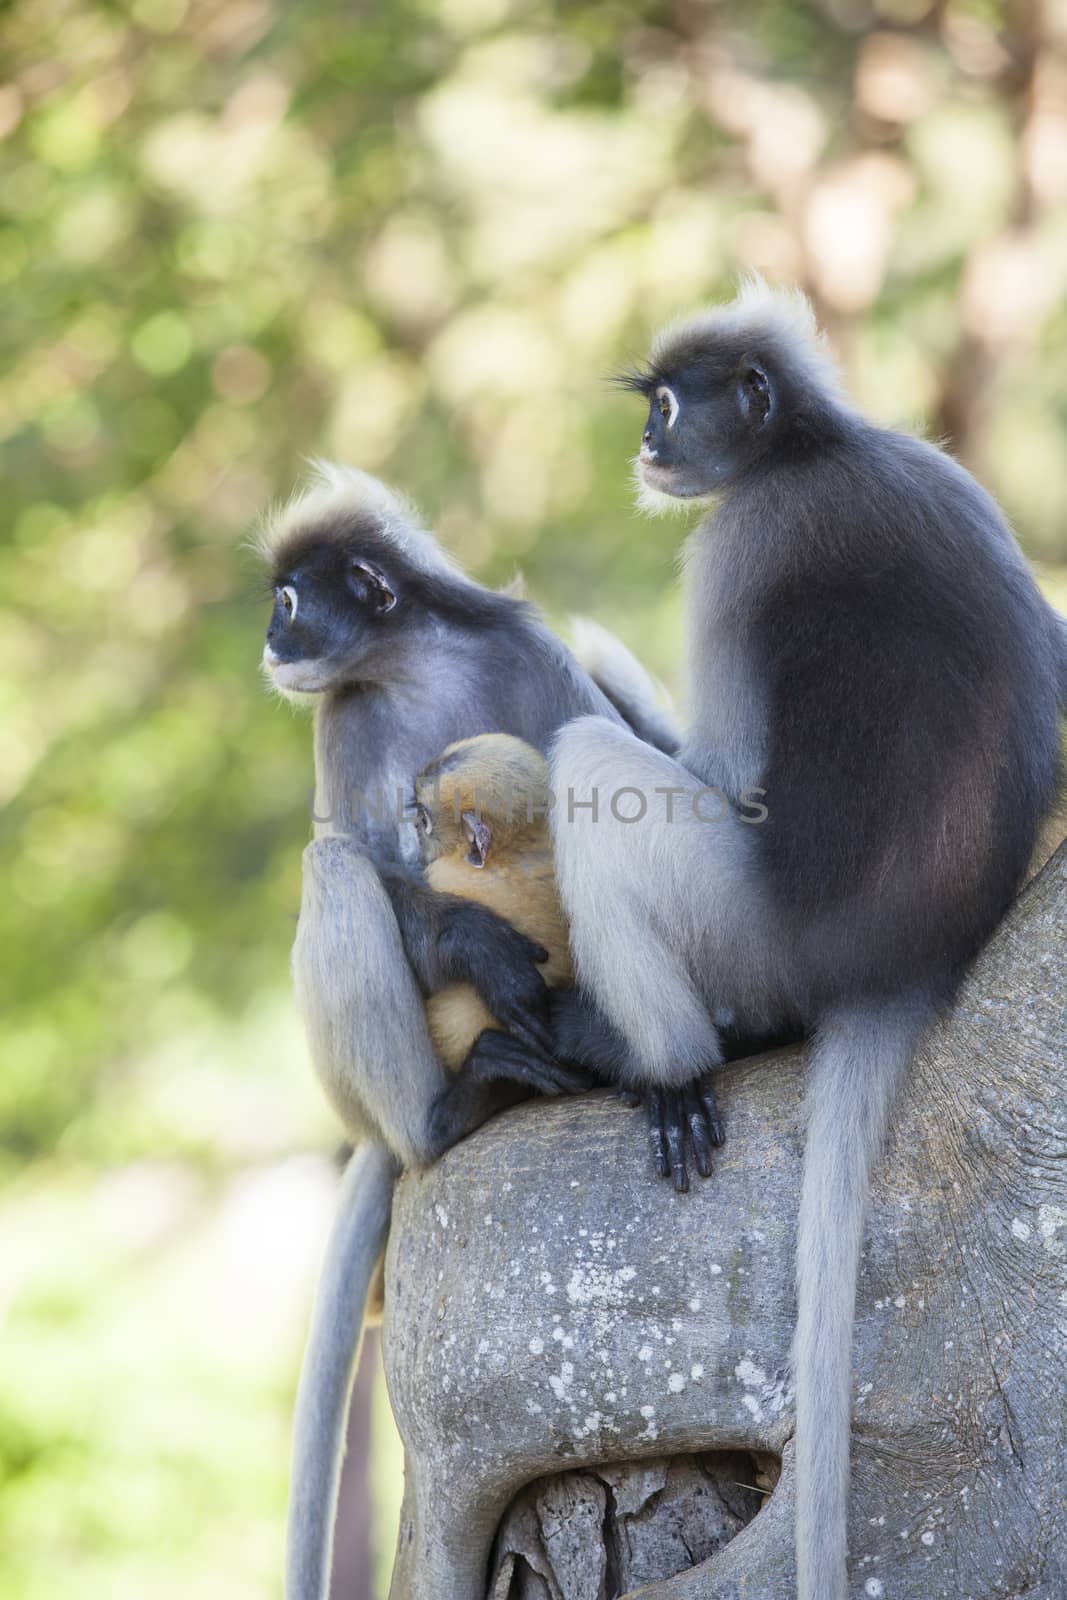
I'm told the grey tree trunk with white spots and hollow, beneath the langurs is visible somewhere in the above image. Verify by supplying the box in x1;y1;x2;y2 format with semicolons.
386;846;1067;1600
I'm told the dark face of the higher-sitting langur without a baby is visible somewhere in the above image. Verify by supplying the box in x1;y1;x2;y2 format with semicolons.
629;350;774;499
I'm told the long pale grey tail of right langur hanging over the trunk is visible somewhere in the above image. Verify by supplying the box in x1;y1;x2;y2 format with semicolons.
793;1003;929;1600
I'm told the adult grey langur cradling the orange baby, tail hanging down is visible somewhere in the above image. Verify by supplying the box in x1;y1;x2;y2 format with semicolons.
261;466;687;1600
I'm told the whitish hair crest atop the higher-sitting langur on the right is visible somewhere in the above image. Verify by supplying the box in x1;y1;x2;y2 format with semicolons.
643;272;841;398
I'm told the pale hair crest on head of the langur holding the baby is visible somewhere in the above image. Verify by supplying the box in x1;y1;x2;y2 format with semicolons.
254;458;466;582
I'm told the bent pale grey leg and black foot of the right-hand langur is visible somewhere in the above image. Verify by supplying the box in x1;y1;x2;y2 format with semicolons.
552;717;750;1190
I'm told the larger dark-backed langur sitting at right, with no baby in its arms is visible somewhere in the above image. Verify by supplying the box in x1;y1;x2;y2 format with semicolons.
543;283;1067;1600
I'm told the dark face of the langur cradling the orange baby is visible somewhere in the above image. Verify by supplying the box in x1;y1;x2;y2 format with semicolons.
262;539;398;694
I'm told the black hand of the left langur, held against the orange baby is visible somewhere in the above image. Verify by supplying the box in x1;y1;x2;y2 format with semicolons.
442;901;552;1059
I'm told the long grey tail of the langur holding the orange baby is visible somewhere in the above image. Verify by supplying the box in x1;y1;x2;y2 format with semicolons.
285;1144;397;1600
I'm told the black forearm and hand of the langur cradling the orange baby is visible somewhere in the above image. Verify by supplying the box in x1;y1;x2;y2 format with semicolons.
381;866;552;1054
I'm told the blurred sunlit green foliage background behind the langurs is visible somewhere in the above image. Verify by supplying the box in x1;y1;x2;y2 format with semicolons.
0;0;1067;1600
